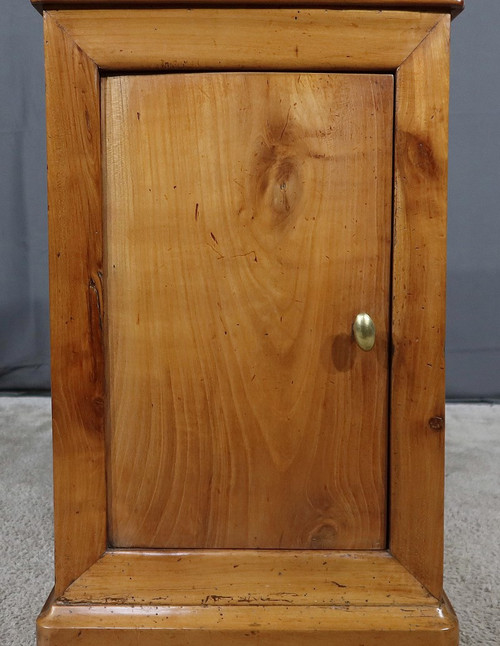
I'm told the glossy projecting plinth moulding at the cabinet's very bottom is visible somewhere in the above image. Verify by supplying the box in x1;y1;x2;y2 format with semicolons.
38;601;458;646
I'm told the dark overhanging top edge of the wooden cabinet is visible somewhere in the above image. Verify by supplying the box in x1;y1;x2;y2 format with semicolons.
31;0;464;16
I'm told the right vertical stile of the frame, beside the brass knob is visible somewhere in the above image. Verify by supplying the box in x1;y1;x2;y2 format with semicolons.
390;16;450;597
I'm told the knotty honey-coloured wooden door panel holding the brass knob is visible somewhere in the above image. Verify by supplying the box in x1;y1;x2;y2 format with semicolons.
103;73;393;549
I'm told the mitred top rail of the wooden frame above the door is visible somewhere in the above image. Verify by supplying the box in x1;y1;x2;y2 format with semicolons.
50;8;441;72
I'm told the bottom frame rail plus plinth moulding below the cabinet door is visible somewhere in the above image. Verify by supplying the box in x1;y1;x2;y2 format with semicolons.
38;550;458;646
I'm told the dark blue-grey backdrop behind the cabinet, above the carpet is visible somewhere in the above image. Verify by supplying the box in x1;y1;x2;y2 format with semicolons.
0;0;500;399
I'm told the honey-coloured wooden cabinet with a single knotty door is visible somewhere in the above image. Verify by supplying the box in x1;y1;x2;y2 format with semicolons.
34;0;461;646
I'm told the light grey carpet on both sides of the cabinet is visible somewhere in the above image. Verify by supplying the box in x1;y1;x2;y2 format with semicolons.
0;397;500;646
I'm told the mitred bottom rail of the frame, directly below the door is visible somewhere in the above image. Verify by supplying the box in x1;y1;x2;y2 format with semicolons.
60;550;436;607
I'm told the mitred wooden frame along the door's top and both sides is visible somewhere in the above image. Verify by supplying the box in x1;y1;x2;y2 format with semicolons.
44;8;450;612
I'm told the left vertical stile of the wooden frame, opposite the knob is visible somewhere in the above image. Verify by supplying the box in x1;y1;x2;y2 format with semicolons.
45;15;106;594
